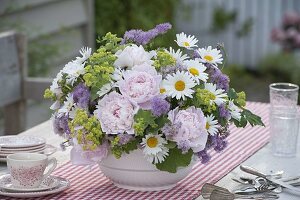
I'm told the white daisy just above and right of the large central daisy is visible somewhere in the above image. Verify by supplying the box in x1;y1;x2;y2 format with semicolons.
184;60;208;84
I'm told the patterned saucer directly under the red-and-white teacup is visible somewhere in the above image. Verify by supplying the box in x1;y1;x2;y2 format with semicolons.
0;174;60;192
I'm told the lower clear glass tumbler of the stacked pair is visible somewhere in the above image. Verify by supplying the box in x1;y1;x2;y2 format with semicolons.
270;111;299;157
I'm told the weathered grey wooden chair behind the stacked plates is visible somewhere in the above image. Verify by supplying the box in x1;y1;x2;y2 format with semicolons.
0;31;51;135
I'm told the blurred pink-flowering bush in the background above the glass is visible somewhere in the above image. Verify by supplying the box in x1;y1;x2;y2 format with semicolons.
259;11;300;89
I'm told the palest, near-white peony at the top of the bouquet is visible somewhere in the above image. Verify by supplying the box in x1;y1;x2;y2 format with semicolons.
114;45;155;69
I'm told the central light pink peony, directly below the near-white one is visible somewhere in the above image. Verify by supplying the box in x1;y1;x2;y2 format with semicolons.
118;64;162;110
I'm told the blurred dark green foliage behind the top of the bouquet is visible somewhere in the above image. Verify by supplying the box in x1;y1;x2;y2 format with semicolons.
95;0;180;48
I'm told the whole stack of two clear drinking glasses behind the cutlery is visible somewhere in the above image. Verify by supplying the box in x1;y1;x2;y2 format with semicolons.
270;83;299;157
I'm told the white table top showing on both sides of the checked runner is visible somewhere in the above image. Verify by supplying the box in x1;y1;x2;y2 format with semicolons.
0;121;300;200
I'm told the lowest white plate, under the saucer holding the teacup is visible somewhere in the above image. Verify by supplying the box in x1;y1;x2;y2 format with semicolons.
0;176;70;198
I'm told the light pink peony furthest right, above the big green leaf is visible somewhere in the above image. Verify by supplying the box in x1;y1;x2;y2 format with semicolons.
168;106;208;153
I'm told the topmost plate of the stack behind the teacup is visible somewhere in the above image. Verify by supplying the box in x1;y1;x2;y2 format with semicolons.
0;135;46;148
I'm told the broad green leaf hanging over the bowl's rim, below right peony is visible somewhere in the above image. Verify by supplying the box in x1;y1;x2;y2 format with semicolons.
156;148;193;173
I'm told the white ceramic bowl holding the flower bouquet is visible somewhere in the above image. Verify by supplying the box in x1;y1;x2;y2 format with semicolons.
99;150;193;191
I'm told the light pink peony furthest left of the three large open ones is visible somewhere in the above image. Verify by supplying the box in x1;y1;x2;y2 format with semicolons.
94;91;138;134
